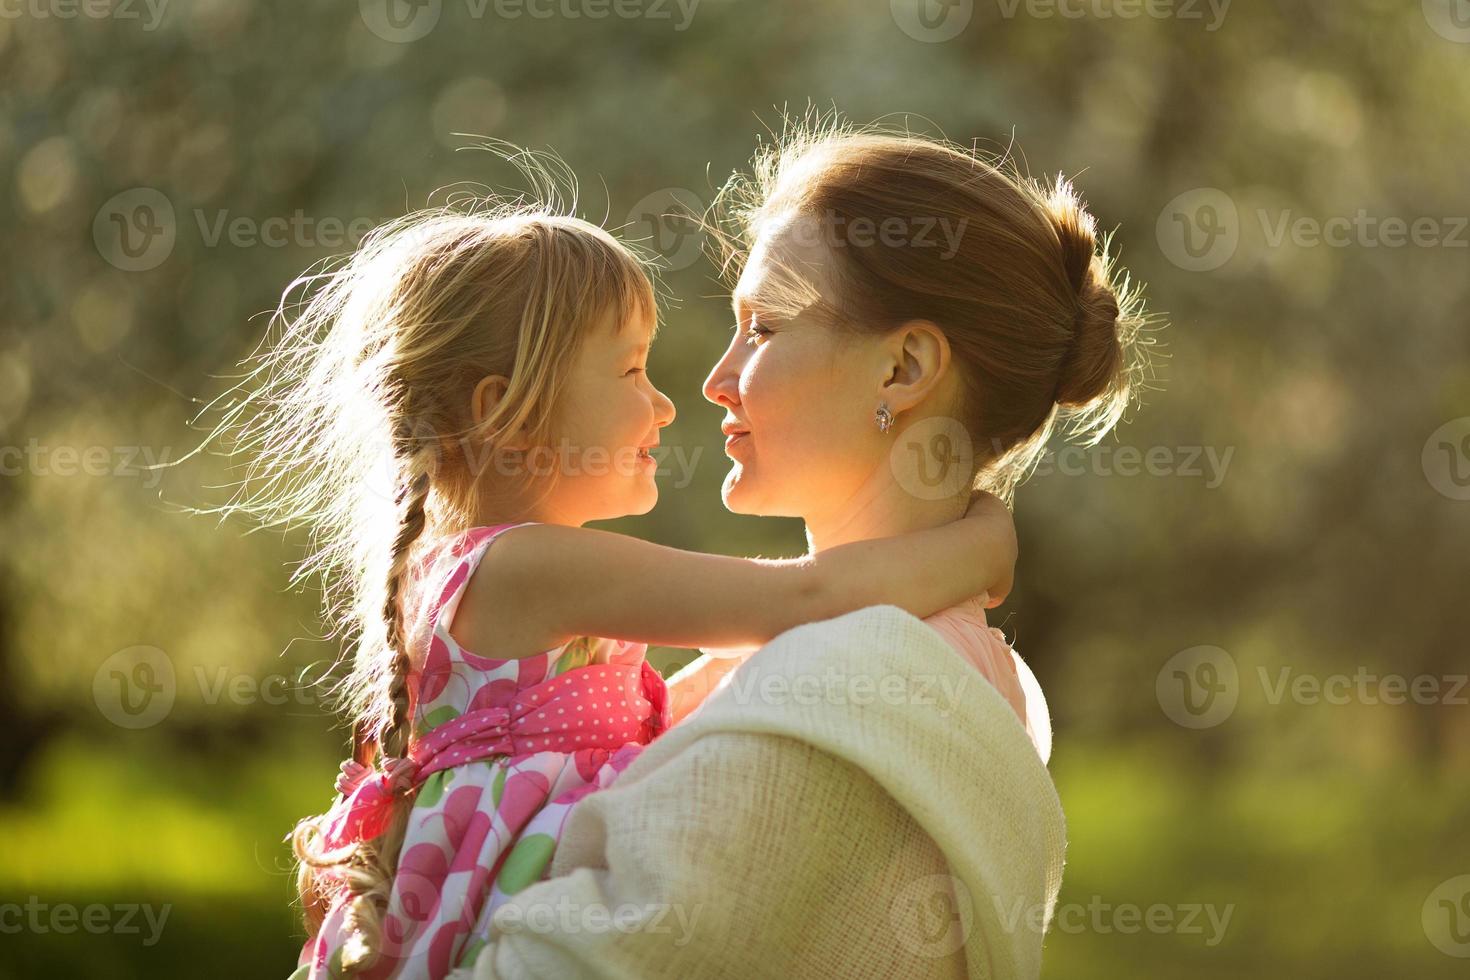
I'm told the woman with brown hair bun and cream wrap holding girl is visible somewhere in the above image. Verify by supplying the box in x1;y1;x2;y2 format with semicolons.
446;131;1142;977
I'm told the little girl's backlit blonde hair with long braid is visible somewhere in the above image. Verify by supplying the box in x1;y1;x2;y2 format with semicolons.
198;182;656;970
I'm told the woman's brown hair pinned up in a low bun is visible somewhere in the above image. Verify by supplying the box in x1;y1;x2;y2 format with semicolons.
706;118;1152;500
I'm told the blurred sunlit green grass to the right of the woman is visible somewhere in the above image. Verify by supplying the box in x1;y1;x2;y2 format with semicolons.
1044;743;1470;979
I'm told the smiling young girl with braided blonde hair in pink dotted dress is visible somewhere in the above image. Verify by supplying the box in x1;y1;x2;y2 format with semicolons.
213;199;1014;980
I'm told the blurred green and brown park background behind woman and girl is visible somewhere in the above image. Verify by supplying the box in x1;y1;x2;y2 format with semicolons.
0;0;1470;979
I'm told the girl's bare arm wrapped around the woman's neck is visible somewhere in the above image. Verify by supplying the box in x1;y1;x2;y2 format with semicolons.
462;494;1016;648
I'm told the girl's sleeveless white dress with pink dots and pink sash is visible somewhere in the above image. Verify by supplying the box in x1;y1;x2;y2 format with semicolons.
291;525;669;980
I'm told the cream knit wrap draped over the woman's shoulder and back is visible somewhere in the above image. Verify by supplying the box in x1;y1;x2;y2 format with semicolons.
451;605;1066;980
